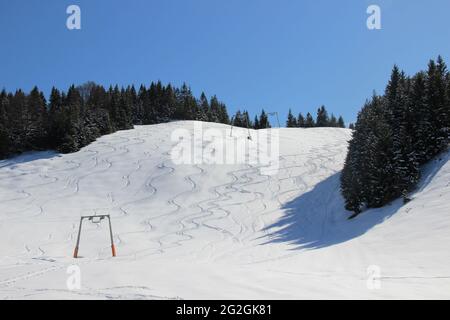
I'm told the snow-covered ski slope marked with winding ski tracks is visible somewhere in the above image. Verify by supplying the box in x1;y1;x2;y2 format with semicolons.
0;122;450;299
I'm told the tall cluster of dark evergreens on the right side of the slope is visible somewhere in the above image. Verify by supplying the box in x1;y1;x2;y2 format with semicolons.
341;57;450;214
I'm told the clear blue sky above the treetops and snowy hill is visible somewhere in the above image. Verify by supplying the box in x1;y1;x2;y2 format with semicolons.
0;0;450;125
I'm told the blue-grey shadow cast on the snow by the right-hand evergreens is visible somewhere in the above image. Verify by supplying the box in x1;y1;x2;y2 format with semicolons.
264;159;448;250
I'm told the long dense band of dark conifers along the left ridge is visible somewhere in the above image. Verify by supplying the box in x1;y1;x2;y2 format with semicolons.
0;81;232;158
